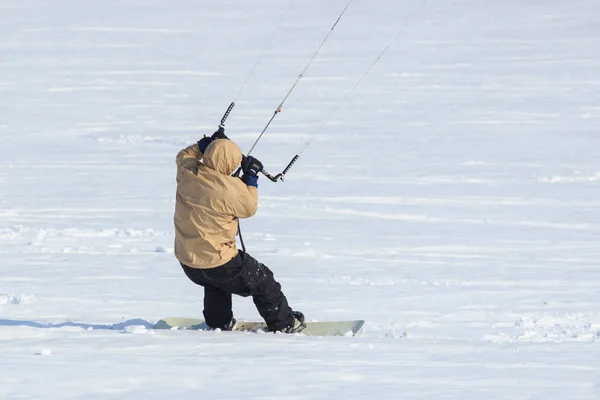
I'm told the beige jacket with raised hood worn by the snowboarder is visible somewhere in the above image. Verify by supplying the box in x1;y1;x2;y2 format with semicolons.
175;139;258;269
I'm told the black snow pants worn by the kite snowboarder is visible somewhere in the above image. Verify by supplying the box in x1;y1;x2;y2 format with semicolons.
181;251;294;331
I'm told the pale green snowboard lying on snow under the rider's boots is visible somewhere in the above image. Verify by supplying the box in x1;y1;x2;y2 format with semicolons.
154;317;365;336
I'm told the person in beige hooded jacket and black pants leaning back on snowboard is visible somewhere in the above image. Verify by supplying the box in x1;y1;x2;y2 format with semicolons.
174;128;306;333
